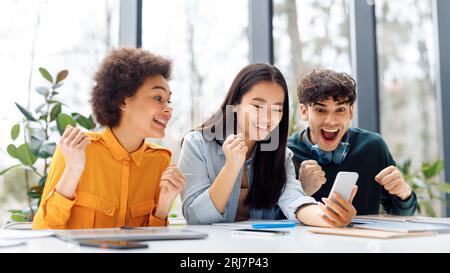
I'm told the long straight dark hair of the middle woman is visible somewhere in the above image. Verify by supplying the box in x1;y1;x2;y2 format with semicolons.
195;64;289;209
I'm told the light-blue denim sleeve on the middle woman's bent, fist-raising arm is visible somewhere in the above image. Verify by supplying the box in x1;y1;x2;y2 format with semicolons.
178;132;225;225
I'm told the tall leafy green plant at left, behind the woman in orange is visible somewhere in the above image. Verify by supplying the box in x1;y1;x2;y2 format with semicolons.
0;67;95;222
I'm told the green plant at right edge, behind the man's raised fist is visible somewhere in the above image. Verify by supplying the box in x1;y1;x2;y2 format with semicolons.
398;159;450;217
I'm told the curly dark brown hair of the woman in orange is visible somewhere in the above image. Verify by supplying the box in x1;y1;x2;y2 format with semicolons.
90;48;172;127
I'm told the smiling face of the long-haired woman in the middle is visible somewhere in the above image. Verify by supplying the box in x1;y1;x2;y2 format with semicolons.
235;81;284;141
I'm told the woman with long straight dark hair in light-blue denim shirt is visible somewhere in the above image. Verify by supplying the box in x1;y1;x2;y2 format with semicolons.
178;64;356;226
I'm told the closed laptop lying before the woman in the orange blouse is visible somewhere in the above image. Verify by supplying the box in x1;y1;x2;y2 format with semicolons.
54;227;208;241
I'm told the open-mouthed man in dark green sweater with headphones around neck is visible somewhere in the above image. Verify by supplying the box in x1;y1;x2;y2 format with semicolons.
288;70;417;215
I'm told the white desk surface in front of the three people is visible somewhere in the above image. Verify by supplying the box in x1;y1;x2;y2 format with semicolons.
0;226;450;253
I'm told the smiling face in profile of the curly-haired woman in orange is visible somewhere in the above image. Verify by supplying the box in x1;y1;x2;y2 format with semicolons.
120;75;172;138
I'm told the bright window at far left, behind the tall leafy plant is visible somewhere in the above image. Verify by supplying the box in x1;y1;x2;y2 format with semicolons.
0;0;120;223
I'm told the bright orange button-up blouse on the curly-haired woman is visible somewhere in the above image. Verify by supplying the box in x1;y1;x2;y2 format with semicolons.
33;128;171;229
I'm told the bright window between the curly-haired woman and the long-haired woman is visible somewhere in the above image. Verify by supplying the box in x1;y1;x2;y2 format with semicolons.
142;0;249;161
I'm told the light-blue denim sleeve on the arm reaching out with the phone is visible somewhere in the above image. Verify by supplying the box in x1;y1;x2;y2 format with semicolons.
278;148;317;221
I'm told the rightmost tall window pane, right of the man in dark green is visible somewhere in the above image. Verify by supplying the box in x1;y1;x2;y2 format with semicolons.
375;0;438;166
